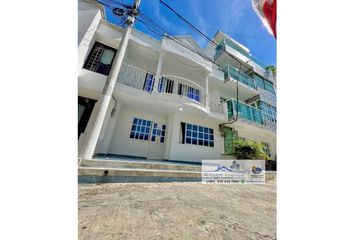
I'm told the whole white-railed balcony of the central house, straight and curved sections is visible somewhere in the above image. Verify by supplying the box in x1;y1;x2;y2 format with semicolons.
118;63;205;106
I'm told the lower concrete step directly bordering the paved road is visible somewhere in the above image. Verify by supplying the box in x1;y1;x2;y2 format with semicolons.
79;166;201;183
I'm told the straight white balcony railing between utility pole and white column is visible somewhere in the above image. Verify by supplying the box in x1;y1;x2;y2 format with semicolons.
118;63;147;90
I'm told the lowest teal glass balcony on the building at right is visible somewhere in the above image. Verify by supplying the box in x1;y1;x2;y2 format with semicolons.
226;99;277;131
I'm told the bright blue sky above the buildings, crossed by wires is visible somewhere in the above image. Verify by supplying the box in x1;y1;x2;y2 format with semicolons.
106;0;276;65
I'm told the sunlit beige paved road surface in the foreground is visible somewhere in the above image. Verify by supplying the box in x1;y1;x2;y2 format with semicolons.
78;181;276;240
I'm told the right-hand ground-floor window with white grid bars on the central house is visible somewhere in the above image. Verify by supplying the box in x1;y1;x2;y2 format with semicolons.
181;122;214;147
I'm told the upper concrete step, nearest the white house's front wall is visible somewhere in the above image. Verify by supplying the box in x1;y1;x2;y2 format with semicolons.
80;159;202;172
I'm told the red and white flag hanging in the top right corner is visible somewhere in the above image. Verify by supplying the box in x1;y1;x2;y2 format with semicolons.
252;0;277;38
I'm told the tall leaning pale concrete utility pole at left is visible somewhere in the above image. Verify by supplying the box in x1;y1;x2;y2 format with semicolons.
82;0;141;159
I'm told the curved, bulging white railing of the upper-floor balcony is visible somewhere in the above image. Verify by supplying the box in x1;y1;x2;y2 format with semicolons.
158;75;205;105
